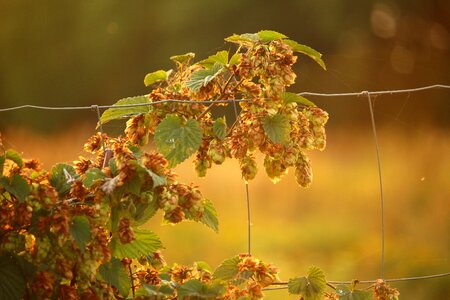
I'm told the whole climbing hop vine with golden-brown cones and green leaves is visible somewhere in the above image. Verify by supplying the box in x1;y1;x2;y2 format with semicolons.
0;31;398;300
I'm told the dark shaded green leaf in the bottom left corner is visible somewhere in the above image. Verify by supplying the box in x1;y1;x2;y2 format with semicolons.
0;254;25;300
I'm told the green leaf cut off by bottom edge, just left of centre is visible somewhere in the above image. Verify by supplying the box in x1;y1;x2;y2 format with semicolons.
177;279;226;299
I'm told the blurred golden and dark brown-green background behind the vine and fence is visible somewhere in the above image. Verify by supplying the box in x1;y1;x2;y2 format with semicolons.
0;0;450;299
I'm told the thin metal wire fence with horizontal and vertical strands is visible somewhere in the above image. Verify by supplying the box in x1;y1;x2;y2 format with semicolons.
0;84;450;291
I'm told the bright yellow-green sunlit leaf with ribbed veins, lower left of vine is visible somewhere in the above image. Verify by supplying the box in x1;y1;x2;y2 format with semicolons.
109;229;162;259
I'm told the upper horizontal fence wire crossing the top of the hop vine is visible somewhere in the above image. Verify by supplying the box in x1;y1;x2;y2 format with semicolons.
0;84;450;112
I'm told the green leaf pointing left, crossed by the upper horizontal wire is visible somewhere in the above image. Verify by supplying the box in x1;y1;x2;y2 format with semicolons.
100;95;151;124
